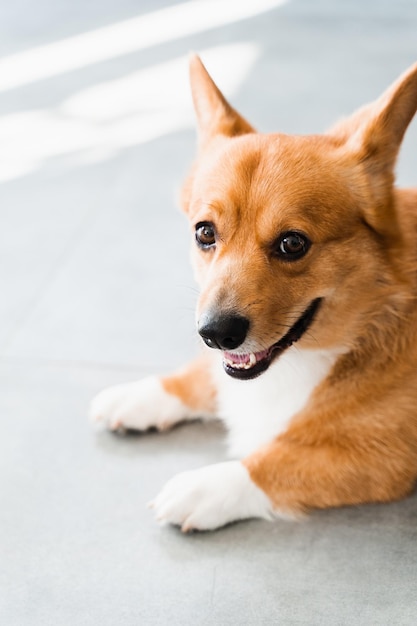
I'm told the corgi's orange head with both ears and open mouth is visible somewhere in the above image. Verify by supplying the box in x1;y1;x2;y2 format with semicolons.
182;57;417;379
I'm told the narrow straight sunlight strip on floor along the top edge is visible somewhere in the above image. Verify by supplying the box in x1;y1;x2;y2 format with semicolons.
0;0;287;92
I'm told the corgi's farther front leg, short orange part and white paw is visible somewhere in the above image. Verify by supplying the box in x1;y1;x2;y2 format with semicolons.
90;353;217;430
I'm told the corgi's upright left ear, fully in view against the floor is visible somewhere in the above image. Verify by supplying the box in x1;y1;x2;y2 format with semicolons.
190;54;255;146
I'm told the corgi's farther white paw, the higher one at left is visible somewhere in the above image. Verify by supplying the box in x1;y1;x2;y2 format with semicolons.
90;376;190;430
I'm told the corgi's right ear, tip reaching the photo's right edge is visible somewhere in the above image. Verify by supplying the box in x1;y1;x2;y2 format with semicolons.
329;63;417;225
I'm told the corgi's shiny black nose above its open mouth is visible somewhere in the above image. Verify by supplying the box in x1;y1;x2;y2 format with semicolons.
198;313;249;350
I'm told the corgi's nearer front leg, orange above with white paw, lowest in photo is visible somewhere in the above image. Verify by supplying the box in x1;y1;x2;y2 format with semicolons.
153;422;415;531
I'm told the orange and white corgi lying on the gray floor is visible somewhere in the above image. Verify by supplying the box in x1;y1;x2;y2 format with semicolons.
91;56;417;532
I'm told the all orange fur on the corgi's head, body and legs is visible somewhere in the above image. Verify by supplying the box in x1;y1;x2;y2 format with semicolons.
163;57;417;511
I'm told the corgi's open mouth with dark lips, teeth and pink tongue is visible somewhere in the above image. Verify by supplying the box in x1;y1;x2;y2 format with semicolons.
223;298;322;380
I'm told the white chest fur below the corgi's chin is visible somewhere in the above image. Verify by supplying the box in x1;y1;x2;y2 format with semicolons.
216;346;340;458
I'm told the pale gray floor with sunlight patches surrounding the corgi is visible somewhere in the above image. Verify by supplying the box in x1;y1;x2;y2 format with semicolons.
0;0;417;626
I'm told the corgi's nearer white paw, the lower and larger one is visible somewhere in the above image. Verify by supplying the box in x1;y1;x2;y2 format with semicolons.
150;461;273;532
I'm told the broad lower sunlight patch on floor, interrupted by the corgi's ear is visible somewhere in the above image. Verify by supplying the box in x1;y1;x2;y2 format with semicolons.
0;43;260;181
